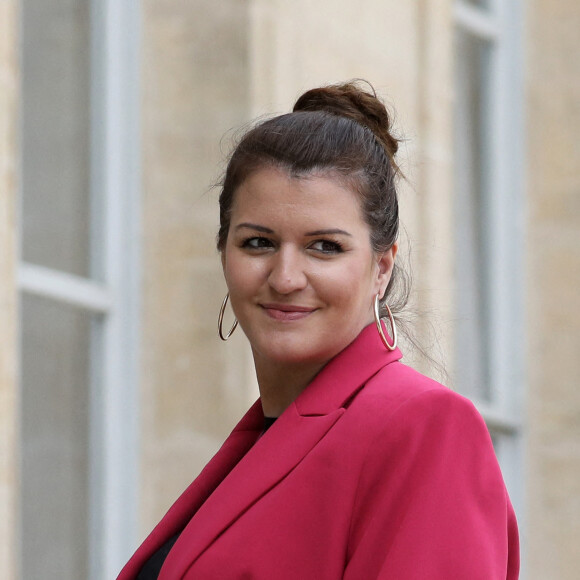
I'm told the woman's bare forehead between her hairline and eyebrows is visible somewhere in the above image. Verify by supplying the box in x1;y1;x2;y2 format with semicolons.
232;168;367;230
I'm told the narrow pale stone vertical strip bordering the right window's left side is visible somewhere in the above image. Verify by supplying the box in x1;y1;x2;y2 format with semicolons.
413;0;454;372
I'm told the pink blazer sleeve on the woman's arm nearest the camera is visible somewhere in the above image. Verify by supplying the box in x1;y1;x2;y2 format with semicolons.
344;389;519;580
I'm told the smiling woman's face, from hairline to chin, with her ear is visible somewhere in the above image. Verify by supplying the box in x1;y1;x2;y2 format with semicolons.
222;168;396;365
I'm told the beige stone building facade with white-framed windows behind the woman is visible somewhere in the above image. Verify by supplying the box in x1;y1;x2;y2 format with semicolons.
0;0;580;580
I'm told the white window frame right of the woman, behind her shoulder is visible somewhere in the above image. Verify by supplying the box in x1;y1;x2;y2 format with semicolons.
454;0;525;544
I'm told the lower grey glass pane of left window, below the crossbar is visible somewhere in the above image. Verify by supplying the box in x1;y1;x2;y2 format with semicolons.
21;295;91;580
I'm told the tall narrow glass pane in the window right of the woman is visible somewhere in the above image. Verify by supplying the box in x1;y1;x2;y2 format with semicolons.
455;30;492;400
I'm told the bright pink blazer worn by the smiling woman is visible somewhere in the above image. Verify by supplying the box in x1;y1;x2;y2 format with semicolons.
118;327;519;580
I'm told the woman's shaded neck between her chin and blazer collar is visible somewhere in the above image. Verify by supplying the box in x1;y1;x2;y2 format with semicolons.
254;353;324;417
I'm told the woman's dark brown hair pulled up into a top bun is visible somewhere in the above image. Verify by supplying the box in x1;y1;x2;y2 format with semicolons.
217;81;408;311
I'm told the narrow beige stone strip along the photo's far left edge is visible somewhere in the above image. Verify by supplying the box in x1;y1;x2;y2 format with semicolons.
0;0;18;580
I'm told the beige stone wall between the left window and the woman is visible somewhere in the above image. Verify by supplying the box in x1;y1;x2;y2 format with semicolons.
141;0;254;533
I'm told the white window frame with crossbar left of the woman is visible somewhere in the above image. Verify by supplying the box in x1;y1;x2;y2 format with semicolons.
17;0;140;580
